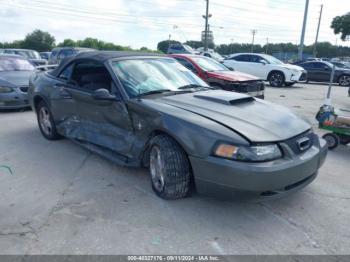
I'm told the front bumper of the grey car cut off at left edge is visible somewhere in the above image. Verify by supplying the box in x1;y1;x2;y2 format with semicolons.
0;90;29;109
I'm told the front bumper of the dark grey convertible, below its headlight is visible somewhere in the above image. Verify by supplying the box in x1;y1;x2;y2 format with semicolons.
190;137;327;196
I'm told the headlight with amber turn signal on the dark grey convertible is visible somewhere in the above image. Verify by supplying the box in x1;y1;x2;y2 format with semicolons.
214;143;282;162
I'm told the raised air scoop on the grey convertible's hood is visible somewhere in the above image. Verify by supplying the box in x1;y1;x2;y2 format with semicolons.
193;92;255;106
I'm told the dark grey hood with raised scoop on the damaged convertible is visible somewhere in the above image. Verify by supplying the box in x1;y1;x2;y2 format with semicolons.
157;90;311;143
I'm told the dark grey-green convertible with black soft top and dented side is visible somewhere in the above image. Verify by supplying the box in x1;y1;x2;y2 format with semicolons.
28;51;327;199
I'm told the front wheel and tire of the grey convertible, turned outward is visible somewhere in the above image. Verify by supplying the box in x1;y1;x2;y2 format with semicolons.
149;135;191;200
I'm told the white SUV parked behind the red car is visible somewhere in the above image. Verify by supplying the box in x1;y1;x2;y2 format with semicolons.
224;53;307;87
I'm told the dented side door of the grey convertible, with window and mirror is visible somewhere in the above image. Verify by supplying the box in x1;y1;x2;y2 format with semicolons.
64;60;134;155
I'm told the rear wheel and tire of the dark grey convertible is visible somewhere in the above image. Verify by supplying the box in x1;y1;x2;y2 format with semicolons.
36;101;62;140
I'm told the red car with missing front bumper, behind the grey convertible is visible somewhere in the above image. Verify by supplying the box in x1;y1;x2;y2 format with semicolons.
168;54;265;99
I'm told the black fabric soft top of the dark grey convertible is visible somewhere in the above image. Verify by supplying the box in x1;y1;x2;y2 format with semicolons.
50;51;164;76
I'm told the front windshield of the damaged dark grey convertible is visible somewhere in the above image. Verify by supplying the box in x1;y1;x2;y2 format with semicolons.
111;58;209;97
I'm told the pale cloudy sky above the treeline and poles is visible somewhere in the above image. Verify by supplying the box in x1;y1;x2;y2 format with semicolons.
0;0;350;49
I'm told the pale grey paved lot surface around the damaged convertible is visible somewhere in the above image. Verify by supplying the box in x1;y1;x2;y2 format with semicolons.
0;84;350;254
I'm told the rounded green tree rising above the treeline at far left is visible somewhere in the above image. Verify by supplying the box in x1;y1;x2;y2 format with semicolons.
21;30;55;52
